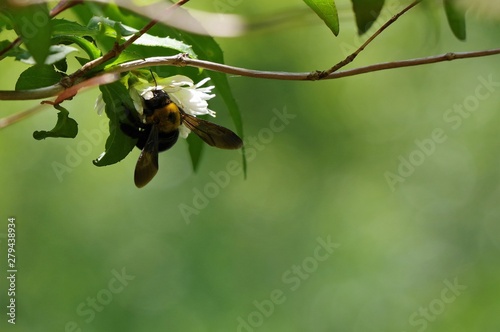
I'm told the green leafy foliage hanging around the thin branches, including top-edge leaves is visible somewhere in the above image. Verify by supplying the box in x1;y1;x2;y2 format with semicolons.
0;0;466;178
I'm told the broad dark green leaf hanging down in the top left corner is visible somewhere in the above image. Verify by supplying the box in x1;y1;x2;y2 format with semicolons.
10;3;52;64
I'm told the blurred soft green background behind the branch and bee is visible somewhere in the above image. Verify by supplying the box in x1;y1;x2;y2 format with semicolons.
0;0;500;332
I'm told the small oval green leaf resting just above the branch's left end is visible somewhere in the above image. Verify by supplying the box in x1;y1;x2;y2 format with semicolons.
16;65;62;90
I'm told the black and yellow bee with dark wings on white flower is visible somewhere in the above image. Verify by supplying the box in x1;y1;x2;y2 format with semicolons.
121;88;243;188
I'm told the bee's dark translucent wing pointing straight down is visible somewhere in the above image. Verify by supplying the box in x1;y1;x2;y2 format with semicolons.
134;125;158;188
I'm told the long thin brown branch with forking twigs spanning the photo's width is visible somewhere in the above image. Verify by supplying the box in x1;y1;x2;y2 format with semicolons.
0;0;500;100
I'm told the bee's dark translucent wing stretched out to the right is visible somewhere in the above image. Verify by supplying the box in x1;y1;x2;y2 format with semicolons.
181;111;243;149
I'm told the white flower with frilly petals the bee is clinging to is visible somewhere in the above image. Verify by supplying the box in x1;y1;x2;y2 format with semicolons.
130;75;215;138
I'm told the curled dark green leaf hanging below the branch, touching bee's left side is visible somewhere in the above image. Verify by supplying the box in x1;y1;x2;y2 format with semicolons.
93;81;137;166
